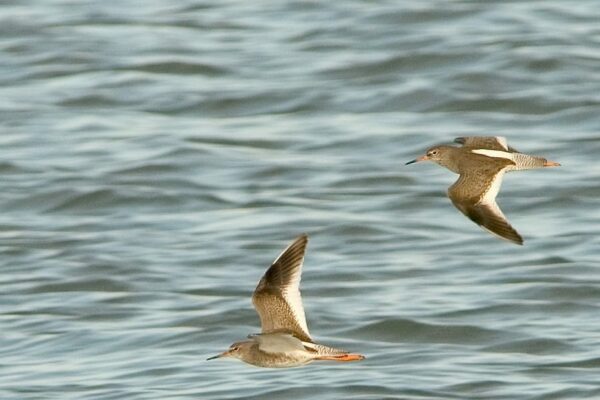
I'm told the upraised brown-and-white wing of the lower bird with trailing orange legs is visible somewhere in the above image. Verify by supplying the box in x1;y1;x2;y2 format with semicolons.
252;235;312;342
